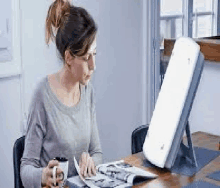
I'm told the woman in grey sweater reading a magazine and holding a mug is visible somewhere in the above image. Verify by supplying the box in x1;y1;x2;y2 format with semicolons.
21;0;102;188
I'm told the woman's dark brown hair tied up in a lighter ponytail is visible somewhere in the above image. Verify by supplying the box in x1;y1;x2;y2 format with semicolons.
45;0;97;59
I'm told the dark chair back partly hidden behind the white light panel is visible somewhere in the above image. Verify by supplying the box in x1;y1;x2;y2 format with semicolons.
131;124;149;154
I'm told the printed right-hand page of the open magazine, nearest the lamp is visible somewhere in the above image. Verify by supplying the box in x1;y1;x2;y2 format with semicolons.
97;160;157;185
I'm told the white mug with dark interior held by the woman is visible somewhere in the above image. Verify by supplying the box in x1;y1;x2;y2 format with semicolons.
53;157;69;187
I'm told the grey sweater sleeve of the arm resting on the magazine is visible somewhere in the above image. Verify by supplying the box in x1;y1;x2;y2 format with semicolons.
89;85;102;165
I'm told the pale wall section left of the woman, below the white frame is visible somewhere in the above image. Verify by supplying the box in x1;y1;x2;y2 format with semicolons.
0;76;21;187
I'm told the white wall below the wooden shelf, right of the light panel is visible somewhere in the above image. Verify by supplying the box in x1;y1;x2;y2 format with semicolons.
189;61;220;136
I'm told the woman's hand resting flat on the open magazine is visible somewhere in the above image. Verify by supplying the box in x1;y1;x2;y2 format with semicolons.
79;152;96;178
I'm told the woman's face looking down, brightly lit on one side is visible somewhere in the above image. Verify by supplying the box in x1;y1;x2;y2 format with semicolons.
68;39;96;85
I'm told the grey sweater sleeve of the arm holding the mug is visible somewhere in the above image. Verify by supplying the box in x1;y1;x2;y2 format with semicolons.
20;88;46;188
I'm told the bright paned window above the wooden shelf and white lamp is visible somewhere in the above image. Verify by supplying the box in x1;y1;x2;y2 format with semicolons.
160;0;219;39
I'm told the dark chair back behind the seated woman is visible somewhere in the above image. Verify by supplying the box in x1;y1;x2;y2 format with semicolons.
13;136;25;188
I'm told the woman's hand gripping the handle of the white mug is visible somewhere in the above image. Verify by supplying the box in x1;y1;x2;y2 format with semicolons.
41;160;62;188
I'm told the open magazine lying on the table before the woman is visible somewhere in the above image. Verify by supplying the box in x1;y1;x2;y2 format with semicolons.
68;156;157;188
